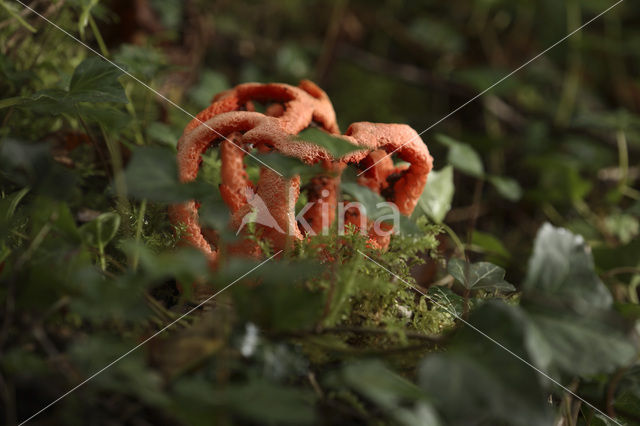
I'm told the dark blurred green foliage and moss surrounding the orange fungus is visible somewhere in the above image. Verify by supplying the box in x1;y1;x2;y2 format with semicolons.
0;0;640;425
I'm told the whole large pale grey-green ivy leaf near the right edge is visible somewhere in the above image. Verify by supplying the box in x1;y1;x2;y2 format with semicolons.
522;223;637;375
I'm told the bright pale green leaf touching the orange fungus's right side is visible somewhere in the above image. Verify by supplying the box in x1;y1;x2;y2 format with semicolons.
412;166;455;223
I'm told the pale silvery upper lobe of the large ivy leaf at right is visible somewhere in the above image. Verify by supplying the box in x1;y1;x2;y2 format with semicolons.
523;223;613;313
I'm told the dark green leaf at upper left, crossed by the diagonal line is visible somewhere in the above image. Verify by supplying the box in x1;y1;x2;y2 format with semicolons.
68;58;129;104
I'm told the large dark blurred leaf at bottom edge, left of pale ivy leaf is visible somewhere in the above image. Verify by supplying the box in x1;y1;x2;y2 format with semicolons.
418;302;552;426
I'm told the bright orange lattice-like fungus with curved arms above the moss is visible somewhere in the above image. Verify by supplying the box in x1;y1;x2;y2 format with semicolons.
170;80;433;264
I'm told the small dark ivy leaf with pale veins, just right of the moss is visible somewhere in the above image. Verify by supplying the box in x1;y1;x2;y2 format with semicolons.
447;259;516;291
